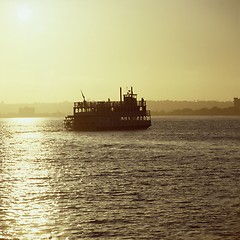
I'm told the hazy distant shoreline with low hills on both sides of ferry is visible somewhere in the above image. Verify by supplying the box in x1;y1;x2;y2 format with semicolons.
0;100;240;118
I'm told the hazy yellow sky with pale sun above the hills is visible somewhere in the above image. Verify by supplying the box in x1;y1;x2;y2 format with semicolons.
0;0;240;103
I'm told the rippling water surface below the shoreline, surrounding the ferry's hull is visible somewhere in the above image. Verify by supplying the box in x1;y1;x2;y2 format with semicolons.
0;117;240;240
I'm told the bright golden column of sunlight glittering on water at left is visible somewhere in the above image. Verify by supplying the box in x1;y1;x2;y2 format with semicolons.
2;118;61;239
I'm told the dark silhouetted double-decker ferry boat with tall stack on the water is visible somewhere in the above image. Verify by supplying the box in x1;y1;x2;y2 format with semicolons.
64;87;151;131
